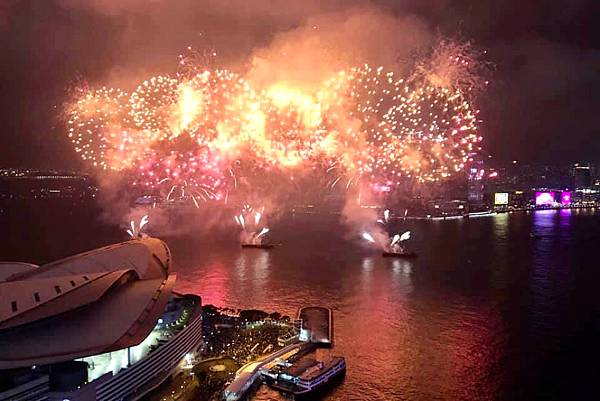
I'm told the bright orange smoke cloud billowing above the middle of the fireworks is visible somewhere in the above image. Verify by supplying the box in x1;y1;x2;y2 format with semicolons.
247;7;432;87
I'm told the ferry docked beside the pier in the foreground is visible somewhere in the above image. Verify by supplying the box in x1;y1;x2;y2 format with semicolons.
268;356;346;399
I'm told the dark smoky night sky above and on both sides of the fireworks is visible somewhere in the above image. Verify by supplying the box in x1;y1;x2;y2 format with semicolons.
0;0;600;168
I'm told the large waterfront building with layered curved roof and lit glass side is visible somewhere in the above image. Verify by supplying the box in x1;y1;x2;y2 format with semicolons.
0;238;202;401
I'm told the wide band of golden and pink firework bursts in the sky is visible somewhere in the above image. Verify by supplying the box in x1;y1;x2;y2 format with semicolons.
67;42;481;199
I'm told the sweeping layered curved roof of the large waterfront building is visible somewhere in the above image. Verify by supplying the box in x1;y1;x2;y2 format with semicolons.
0;238;175;369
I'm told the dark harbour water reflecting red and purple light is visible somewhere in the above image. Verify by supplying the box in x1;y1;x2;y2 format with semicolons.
0;205;600;401
